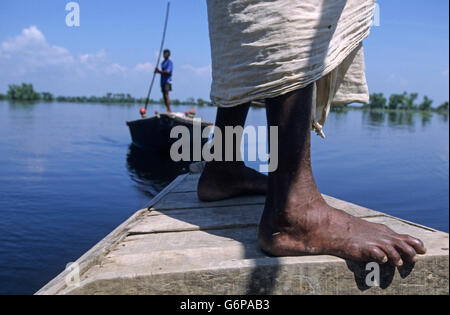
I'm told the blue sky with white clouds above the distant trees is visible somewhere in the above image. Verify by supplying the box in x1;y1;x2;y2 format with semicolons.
0;0;449;106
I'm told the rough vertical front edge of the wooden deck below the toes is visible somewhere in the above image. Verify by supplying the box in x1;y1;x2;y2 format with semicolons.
66;252;448;295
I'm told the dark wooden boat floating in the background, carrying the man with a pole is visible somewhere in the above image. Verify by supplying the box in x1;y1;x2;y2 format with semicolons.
127;113;212;154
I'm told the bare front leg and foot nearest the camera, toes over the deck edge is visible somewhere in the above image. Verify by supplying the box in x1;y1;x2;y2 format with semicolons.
258;85;425;266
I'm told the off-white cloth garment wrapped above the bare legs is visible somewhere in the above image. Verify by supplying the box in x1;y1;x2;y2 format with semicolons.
207;0;375;136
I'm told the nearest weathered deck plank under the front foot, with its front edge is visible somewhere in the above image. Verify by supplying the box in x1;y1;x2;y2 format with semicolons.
67;217;448;294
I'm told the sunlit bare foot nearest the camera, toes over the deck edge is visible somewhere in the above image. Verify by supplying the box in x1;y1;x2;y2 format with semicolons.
259;197;426;266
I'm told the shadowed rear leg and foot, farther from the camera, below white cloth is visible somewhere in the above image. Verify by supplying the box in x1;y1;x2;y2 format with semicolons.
197;104;267;201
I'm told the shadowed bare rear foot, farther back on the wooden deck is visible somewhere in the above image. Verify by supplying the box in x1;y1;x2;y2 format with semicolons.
197;162;267;201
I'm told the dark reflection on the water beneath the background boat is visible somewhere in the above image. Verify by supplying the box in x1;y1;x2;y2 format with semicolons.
127;144;189;197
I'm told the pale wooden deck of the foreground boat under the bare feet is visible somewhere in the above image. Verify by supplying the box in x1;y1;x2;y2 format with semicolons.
37;165;449;294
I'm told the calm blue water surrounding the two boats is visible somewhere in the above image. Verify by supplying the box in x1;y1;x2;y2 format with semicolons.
0;102;449;294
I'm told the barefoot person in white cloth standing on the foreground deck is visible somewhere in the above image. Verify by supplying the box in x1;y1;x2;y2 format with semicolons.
198;0;426;266
